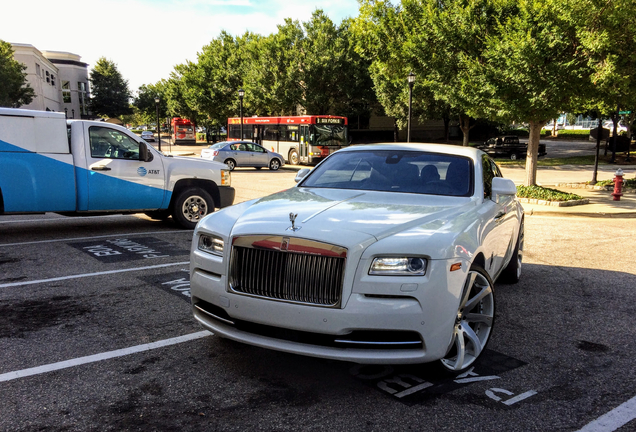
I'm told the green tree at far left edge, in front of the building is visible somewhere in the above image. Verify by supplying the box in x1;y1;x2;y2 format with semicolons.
0;40;35;108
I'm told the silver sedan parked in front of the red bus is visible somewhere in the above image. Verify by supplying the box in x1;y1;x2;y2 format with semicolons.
201;141;285;171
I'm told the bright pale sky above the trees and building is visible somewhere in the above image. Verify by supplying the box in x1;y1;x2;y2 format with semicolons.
0;0;358;91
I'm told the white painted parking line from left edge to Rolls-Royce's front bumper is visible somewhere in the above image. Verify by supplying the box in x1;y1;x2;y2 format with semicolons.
0;330;212;382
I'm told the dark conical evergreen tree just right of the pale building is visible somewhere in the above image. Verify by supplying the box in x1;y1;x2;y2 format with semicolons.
90;57;132;117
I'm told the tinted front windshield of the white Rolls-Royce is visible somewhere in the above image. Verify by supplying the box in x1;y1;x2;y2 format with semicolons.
300;150;473;196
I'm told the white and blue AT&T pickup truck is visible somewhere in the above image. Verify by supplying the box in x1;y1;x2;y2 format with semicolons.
0;108;234;229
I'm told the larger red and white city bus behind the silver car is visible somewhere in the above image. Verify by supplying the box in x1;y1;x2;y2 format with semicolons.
227;115;349;165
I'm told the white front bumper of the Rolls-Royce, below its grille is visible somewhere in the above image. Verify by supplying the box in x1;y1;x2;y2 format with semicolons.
190;250;466;364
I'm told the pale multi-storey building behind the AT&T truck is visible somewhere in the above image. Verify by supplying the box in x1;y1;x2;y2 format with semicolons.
11;43;90;118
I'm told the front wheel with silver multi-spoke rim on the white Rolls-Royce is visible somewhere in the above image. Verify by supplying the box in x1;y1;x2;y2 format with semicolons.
439;265;495;375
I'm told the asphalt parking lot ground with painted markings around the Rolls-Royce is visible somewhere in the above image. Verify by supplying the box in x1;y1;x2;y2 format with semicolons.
0;197;636;432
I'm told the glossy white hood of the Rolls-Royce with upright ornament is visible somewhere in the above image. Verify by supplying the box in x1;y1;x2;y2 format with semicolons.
226;188;475;245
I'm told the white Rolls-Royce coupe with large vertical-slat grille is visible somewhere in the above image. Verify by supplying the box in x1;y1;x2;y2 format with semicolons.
190;144;524;373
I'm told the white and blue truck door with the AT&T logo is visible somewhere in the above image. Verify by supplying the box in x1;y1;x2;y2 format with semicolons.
86;126;166;211
